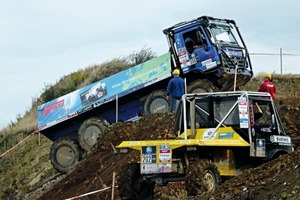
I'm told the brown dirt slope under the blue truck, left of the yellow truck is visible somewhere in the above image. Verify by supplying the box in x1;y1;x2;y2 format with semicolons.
39;113;175;200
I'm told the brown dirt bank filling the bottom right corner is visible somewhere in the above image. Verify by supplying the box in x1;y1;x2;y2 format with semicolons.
192;148;300;200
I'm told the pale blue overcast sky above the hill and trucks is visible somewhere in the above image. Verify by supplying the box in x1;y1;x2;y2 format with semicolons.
0;0;300;129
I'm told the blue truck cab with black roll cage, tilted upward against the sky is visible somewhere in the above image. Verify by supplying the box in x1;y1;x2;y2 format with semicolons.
163;16;253;91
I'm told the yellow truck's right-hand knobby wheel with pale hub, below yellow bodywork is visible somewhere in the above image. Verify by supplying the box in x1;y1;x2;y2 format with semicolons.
185;159;221;196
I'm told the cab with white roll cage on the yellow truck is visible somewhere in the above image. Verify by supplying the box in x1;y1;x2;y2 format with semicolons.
175;91;293;162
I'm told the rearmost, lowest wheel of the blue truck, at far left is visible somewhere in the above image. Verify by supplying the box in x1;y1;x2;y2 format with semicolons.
50;139;81;173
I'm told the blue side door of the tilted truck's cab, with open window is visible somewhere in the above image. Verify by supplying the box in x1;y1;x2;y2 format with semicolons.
175;26;219;73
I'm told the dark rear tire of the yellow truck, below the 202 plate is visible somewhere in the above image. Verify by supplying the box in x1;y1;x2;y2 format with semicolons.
118;163;154;200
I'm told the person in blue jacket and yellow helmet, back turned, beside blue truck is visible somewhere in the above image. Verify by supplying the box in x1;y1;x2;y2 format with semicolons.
167;69;184;112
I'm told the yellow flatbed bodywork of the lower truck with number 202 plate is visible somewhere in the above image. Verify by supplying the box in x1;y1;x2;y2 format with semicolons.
117;127;250;176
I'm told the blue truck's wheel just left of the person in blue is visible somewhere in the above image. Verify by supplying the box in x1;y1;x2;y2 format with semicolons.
144;90;171;115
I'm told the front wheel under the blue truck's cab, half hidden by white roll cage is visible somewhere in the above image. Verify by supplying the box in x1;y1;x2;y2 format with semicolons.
187;79;219;93
